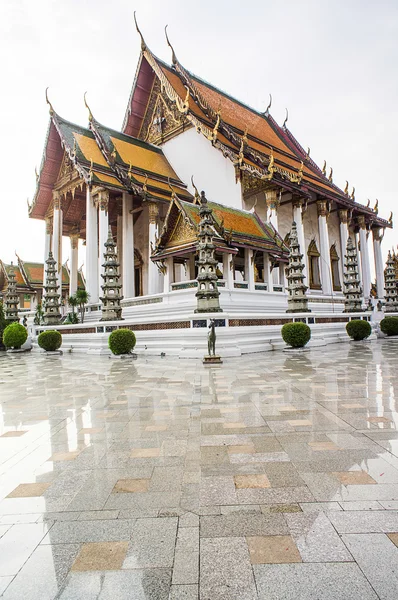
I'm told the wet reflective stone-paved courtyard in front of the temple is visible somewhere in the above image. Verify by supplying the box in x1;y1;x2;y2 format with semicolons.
0;339;398;600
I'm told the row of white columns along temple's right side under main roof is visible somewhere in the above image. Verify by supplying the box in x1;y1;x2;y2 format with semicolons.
265;189;384;299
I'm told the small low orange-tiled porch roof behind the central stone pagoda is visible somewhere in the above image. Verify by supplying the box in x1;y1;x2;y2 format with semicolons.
152;198;288;260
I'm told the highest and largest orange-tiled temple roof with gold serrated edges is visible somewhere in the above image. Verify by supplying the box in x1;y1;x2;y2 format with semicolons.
123;43;392;227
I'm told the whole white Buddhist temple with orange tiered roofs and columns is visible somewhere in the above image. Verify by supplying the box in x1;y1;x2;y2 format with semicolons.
29;19;392;356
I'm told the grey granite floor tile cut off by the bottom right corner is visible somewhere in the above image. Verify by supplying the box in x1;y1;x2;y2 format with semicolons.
342;533;398;600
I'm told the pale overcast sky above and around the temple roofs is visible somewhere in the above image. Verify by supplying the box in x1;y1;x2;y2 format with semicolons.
0;0;398;272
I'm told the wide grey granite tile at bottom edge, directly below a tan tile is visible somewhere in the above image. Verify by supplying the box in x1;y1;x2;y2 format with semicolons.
253;563;378;600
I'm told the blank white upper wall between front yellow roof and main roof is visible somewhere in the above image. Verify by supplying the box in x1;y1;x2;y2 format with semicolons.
162;128;243;208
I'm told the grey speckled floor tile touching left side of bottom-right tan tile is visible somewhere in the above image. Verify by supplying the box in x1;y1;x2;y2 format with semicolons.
200;537;257;600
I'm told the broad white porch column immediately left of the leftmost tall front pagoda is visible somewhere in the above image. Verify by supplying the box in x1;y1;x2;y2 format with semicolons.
86;186;98;304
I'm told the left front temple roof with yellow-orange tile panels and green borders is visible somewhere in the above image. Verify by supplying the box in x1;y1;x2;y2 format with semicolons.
29;110;192;220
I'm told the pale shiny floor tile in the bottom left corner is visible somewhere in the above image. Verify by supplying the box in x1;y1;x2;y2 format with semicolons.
3;544;79;600
